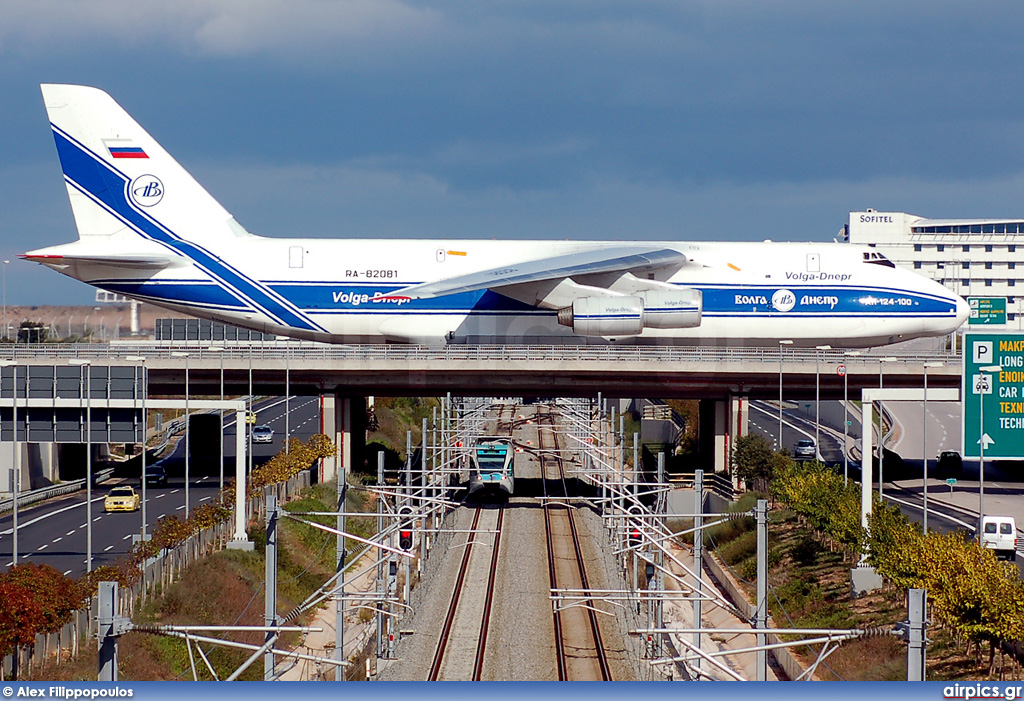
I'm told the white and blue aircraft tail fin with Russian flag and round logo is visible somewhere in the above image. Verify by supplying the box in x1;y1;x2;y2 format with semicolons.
41;84;249;245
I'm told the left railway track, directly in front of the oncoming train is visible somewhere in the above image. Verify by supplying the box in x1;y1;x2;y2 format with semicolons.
428;506;505;682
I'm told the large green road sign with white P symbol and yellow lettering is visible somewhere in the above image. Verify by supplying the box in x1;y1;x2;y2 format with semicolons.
961;332;1024;459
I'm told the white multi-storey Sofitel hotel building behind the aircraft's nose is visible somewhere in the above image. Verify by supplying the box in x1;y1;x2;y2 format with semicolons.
841;210;1024;332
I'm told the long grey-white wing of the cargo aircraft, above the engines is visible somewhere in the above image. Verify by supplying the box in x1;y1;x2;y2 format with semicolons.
388;246;689;299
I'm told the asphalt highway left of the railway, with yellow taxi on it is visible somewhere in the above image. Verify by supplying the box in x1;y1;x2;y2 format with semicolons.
0;397;321;576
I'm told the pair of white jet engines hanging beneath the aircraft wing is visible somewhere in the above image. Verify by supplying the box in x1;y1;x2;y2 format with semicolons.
558;290;702;336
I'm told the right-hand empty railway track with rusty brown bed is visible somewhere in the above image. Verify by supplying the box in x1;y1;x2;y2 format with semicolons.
537;411;611;682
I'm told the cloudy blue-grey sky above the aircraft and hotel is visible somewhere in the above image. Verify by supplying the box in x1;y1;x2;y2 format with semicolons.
0;0;1024;304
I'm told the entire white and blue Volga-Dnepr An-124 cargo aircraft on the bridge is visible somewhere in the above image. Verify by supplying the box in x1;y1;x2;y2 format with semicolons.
24;85;968;347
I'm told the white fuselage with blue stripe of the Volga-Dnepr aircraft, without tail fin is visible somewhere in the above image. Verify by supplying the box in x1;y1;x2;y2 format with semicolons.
51;236;967;347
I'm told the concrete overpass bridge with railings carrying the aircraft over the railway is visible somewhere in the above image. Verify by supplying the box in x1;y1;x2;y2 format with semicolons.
0;341;962;480
